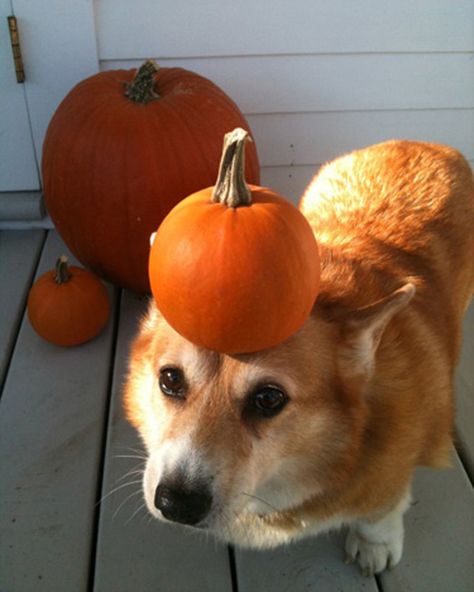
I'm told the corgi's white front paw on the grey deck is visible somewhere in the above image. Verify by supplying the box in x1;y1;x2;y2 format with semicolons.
345;492;411;576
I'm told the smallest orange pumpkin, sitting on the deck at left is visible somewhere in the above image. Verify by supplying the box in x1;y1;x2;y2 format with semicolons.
27;256;110;346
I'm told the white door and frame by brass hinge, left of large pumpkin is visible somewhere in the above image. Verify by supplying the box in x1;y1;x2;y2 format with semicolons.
0;0;99;220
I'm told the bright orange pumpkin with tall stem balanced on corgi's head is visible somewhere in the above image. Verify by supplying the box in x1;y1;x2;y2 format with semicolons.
149;129;320;353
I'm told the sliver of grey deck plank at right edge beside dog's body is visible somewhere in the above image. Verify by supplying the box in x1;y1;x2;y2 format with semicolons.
456;302;474;481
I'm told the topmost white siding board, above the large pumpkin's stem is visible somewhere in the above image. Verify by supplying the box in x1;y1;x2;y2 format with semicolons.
95;0;474;59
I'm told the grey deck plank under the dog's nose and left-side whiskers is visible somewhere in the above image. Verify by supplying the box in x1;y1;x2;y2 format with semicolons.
94;292;232;592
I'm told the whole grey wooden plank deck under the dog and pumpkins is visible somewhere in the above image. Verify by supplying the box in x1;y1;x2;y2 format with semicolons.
0;230;474;592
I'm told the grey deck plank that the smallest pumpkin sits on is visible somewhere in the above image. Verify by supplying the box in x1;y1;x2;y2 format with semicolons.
0;233;113;592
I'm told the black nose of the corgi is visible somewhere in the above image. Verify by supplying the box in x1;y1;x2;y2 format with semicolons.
155;482;212;525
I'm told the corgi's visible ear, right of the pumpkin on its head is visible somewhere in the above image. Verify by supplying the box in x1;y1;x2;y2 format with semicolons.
339;283;416;379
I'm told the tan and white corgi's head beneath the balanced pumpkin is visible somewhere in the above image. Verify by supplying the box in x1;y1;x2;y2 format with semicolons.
125;285;414;537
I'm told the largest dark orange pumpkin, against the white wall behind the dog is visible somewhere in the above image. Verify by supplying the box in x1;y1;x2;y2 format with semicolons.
42;61;259;292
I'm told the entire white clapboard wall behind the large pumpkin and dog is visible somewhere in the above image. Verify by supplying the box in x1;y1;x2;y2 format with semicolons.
95;0;474;200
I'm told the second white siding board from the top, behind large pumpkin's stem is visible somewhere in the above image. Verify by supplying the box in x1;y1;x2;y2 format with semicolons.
103;53;474;114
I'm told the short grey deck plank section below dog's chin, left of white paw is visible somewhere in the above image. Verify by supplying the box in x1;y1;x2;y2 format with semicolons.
236;533;378;592
